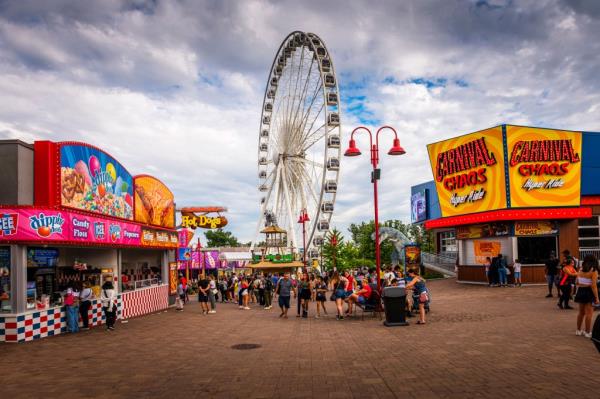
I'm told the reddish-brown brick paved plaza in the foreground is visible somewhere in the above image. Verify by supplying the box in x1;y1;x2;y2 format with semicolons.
0;280;600;399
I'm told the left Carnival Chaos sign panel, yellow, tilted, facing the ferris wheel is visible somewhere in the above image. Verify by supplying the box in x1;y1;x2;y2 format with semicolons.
427;126;506;217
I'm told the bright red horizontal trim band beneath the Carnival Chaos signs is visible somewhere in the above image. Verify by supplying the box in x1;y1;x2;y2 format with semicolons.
425;208;592;229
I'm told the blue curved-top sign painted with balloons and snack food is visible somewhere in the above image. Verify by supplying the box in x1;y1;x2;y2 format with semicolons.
60;144;133;220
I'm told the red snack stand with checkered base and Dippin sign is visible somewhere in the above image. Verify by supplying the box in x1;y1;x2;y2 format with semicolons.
0;141;178;342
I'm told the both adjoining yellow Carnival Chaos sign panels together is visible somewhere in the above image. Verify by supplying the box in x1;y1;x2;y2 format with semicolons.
427;126;582;217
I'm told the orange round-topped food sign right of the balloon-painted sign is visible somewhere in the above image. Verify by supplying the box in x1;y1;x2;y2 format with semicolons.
134;175;175;228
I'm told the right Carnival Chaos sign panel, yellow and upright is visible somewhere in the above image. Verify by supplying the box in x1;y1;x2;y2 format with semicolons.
506;126;582;208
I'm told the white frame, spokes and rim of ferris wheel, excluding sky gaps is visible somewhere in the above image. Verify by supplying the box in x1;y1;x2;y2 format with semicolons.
252;31;342;257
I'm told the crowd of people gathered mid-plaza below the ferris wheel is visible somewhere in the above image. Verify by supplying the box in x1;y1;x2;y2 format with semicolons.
176;267;429;324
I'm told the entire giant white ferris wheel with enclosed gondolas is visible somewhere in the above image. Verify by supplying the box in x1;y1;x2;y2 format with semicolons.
253;31;341;258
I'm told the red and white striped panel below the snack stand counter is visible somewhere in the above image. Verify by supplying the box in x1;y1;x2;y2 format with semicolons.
121;284;169;319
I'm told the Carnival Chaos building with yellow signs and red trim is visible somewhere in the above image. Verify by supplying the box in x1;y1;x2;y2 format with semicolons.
411;125;600;283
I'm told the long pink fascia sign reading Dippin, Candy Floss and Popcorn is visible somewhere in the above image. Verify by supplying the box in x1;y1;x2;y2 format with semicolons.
0;209;142;246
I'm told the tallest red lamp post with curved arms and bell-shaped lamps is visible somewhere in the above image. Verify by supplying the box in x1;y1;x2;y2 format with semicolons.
344;126;406;291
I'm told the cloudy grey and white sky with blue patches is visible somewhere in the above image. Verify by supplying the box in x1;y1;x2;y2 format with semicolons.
0;0;600;244
